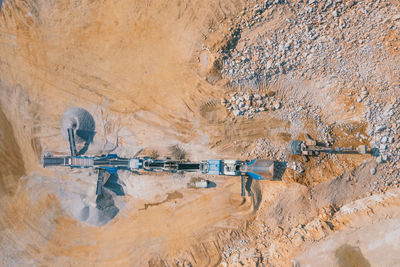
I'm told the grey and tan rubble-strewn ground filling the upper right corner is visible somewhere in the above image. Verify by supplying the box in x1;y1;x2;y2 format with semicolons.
214;1;400;186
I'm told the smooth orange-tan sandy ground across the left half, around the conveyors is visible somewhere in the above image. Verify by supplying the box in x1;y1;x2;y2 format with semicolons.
0;1;260;266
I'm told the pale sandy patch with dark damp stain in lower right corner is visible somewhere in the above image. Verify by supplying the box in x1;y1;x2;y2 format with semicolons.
296;190;400;266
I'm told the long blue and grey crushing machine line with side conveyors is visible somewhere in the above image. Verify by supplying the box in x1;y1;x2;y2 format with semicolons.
43;108;274;196
